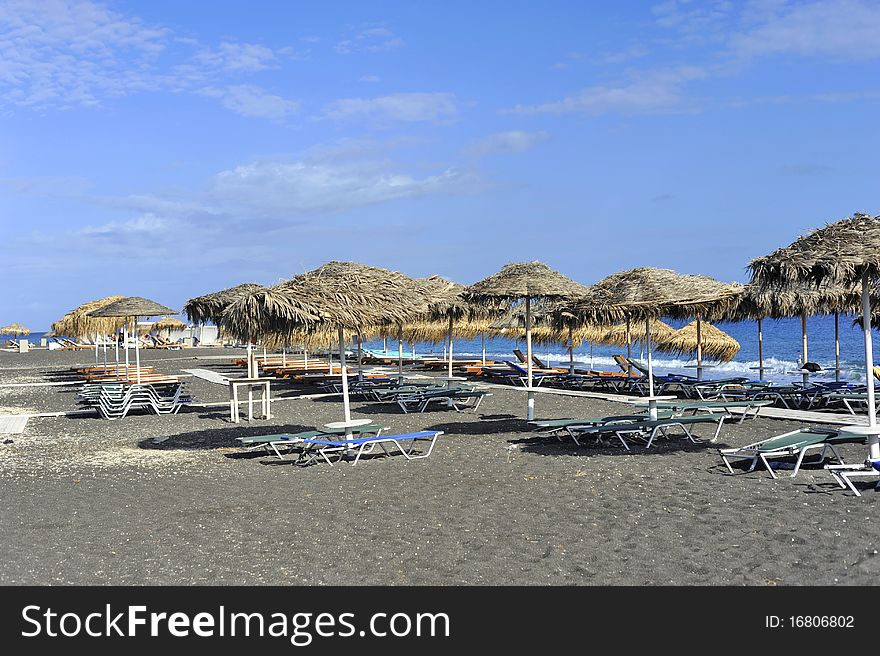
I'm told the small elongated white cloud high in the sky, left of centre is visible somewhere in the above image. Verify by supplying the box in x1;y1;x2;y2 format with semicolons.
324;92;458;122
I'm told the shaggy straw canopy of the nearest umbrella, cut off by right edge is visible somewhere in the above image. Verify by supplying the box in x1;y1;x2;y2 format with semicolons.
749;212;880;288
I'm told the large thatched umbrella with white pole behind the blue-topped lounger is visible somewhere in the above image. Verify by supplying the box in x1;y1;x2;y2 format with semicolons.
223;262;430;434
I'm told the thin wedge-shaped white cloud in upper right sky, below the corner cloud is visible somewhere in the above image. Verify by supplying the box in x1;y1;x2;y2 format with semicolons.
509;67;706;114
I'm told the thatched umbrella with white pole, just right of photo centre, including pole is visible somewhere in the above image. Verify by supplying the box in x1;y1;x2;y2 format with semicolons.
465;261;589;420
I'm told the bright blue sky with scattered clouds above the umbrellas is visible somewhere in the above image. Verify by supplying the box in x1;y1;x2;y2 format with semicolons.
0;0;880;330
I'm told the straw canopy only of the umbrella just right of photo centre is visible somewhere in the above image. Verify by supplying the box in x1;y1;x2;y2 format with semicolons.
465;261;588;302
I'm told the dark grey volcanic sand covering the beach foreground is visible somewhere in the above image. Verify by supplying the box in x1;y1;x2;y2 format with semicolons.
0;349;880;585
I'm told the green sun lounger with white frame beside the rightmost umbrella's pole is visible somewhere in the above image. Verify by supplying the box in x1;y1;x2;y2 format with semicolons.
718;428;864;478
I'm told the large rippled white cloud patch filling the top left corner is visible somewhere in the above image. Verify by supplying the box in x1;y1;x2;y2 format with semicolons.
0;0;300;119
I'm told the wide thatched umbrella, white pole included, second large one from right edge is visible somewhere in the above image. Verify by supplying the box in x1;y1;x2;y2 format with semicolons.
557;267;742;417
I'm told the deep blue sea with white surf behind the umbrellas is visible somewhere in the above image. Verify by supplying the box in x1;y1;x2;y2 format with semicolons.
6;315;880;383
